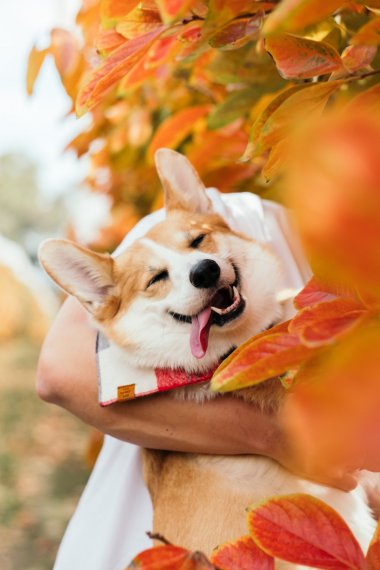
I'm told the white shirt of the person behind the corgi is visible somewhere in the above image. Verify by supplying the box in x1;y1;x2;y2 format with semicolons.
54;192;310;570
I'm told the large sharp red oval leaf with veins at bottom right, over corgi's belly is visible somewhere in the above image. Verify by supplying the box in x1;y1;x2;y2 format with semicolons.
248;494;365;570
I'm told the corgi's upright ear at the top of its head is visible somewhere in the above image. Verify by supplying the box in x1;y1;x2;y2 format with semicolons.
154;148;212;214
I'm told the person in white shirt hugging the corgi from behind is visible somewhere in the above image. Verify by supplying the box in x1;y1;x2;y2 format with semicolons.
37;189;355;570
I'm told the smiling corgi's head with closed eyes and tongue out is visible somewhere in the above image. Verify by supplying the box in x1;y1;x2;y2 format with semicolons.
39;149;281;371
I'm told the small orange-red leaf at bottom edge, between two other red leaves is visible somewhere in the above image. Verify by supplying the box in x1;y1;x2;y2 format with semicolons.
211;536;274;570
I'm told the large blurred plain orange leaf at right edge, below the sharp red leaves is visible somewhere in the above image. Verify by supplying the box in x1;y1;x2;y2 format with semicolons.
282;318;380;471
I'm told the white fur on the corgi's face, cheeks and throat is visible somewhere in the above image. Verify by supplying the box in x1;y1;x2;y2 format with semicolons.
114;234;282;371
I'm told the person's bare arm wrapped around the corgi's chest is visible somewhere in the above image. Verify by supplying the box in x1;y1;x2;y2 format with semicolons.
37;292;355;489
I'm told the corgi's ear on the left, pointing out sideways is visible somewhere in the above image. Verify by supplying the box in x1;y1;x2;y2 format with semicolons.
38;239;114;315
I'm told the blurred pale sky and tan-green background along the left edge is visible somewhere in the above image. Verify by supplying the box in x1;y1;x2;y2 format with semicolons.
0;0;108;570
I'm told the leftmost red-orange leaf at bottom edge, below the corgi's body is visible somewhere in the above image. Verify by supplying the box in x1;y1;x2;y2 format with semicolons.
125;545;215;570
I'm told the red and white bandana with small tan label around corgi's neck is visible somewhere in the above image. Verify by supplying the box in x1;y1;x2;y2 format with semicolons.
96;332;216;406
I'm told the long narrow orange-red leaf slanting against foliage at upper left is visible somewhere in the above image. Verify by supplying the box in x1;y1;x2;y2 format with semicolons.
76;26;164;116
